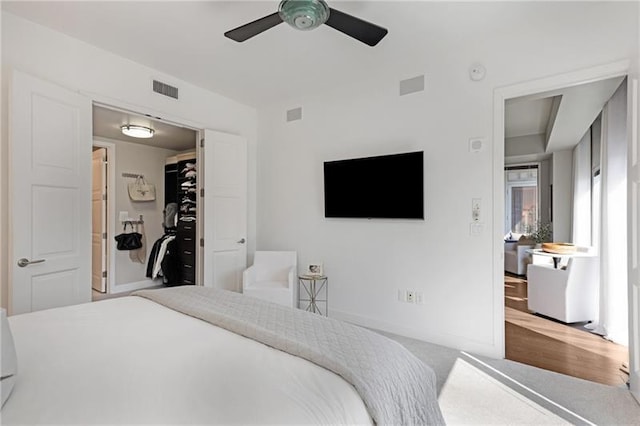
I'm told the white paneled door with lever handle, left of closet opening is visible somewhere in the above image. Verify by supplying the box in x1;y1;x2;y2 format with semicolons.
9;71;92;314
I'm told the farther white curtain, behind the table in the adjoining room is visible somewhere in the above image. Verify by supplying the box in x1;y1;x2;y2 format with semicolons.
571;131;593;247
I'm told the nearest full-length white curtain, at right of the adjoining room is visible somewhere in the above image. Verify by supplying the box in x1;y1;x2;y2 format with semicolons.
593;80;629;345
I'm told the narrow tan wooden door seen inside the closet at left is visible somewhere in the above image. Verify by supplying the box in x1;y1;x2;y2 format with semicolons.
91;148;107;293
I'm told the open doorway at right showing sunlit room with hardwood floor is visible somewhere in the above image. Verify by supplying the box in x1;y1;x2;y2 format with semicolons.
503;76;629;385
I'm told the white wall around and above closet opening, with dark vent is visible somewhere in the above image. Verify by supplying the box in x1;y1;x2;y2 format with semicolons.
0;12;257;307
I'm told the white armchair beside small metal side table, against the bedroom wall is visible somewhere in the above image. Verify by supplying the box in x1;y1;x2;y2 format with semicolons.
242;251;298;308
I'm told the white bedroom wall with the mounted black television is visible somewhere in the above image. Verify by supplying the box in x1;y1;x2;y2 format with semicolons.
257;2;638;355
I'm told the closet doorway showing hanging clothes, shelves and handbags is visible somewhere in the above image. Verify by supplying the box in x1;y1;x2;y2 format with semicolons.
92;103;203;300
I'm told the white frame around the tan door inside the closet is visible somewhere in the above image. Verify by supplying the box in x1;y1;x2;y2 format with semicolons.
93;136;116;294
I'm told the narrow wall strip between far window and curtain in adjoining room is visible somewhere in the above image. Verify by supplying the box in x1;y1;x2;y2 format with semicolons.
551;150;573;242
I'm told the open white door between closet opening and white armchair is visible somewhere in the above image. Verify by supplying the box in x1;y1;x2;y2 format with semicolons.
202;130;247;291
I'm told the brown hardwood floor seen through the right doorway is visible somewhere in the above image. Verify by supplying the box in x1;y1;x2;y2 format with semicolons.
504;275;629;386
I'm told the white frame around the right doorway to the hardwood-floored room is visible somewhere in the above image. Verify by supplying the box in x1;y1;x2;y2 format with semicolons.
493;60;639;358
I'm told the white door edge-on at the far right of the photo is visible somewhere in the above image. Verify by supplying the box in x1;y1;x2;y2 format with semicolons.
627;78;640;401
